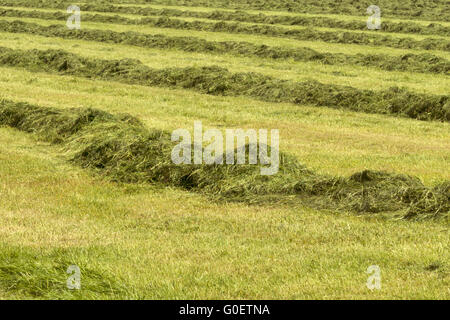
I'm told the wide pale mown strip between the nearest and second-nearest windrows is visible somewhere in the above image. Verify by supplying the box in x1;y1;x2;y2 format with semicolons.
0;68;450;184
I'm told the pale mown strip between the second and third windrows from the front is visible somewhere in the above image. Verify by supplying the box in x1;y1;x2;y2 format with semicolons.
0;33;450;95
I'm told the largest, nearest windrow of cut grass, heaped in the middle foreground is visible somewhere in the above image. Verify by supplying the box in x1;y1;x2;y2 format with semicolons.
0;100;450;219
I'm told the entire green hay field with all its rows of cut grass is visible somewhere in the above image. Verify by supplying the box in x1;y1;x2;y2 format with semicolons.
0;0;450;299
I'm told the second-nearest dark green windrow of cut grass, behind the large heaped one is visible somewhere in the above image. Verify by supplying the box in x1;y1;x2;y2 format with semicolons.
0;47;450;121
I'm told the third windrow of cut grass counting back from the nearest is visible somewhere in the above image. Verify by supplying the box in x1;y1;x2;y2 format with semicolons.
0;20;450;74
